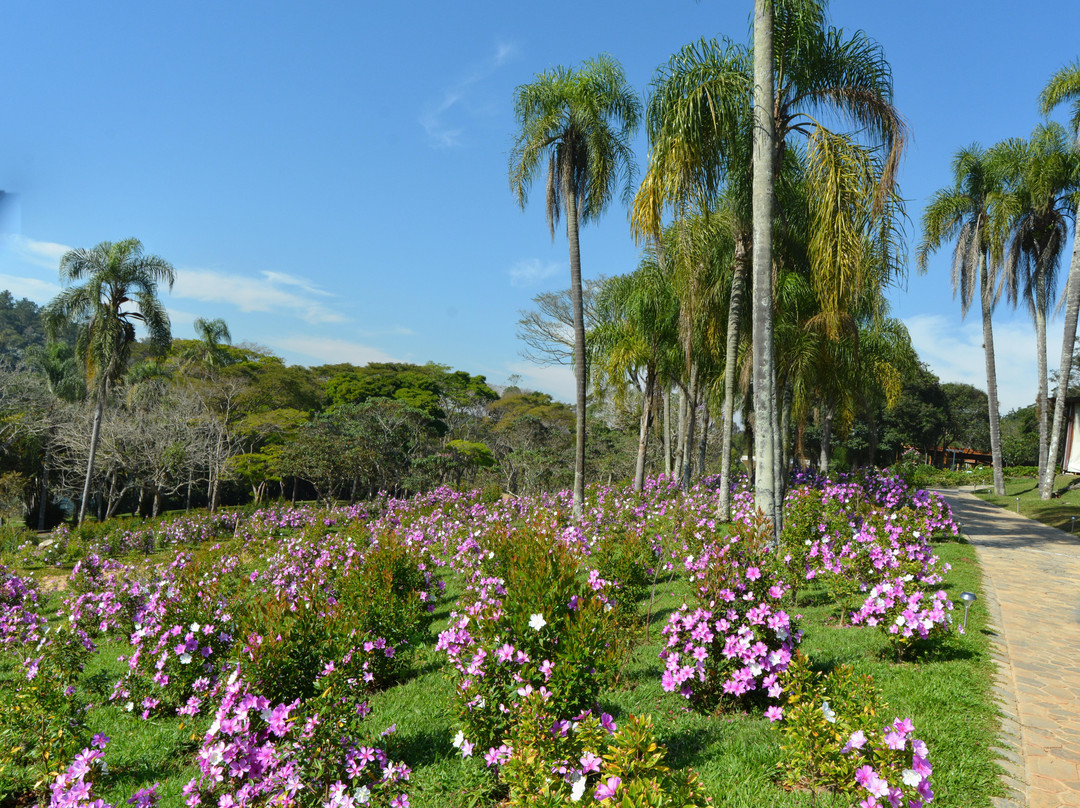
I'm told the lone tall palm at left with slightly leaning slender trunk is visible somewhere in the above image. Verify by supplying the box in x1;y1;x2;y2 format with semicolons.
42;239;174;523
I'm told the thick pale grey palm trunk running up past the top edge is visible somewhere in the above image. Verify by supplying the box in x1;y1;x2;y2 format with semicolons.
753;0;775;529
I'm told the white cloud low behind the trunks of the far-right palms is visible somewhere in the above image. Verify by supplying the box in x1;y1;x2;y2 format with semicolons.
904;312;1045;415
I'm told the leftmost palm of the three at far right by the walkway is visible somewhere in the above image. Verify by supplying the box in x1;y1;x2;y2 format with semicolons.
917;144;1008;496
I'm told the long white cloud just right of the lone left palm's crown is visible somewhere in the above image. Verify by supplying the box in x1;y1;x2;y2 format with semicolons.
173;269;345;324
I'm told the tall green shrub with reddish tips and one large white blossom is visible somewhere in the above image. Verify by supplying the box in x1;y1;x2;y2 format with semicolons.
437;526;618;750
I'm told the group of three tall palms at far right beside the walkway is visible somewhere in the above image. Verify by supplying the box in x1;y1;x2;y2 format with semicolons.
917;63;1080;499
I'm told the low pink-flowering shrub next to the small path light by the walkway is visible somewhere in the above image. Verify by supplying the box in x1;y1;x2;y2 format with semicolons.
851;576;962;658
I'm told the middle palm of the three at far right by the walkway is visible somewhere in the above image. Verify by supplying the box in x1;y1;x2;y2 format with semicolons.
990;123;1080;481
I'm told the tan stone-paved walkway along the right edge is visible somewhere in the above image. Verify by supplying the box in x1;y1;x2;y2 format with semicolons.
939;490;1080;808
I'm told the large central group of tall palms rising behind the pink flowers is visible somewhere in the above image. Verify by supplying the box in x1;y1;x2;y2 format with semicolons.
510;0;914;529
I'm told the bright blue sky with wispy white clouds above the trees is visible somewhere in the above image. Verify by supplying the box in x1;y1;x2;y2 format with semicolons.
0;0;1080;410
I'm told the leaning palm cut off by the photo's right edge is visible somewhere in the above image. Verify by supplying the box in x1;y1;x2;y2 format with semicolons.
1039;62;1080;499
